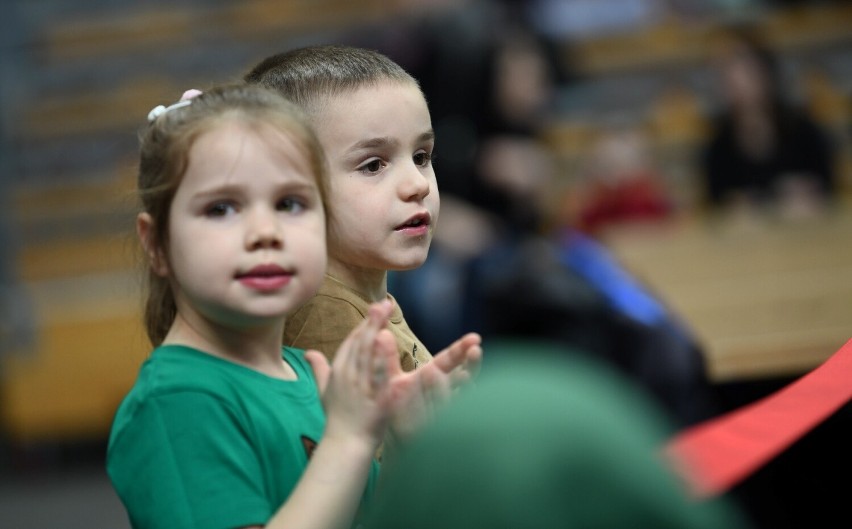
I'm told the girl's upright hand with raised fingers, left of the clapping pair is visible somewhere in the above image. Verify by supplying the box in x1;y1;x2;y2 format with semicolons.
305;302;399;446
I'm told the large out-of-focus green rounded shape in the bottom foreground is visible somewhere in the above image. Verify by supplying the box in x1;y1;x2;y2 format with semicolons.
366;340;748;529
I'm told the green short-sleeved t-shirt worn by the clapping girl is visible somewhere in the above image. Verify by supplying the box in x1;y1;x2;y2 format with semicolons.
107;345;378;529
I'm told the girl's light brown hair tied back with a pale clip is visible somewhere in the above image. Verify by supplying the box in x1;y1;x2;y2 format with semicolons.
137;84;327;346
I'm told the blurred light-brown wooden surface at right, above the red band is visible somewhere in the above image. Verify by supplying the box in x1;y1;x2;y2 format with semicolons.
606;208;852;382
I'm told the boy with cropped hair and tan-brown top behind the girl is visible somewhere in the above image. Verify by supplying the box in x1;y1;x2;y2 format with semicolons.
245;45;480;371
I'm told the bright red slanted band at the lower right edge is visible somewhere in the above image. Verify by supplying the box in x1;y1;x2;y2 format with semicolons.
664;340;852;497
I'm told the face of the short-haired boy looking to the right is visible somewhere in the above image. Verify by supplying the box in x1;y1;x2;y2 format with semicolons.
314;81;440;274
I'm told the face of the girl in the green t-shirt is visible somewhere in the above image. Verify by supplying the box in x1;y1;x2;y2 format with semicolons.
153;120;326;328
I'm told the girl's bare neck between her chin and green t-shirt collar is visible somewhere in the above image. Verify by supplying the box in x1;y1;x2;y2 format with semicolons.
163;310;296;380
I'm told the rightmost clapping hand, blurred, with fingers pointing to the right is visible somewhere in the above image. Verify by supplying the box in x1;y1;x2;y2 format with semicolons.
388;333;482;438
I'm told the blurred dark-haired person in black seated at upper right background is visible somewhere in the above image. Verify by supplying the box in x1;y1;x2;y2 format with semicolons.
702;25;836;217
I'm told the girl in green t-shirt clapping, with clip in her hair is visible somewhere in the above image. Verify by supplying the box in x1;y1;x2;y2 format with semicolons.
107;86;466;529
